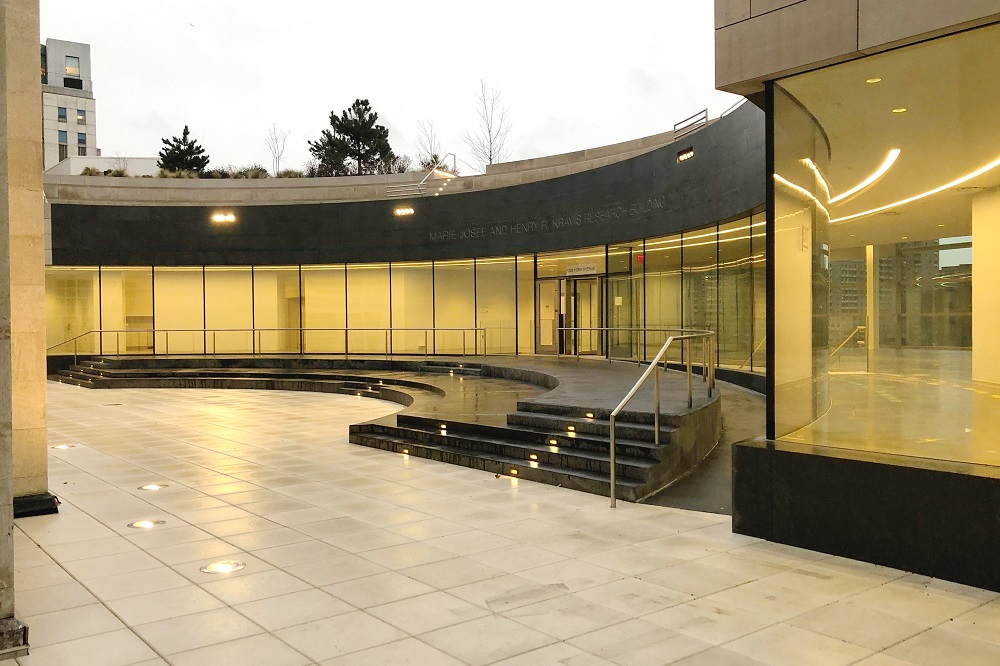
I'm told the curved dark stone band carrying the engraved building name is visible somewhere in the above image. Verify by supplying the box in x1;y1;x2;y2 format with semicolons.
52;104;766;266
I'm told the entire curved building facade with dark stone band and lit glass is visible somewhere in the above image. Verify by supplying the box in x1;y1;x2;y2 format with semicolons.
46;104;766;372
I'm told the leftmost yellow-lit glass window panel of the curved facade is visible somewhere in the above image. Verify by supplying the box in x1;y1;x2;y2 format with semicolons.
45;268;100;356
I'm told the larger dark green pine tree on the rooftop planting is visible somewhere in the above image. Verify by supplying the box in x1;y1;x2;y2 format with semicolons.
309;99;398;176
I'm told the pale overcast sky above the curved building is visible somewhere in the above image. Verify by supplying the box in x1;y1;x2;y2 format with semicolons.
41;0;738;173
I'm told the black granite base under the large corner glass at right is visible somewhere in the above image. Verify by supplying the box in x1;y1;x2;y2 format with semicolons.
733;441;1000;591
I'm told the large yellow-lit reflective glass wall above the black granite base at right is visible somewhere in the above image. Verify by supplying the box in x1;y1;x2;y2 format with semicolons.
772;26;1000;464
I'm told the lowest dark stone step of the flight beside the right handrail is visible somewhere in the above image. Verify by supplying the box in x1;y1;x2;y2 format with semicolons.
350;433;640;502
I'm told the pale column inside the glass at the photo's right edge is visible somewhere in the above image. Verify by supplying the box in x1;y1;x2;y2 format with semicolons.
972;190;1000;384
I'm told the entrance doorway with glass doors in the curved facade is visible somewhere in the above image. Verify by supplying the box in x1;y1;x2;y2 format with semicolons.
535;277;604;356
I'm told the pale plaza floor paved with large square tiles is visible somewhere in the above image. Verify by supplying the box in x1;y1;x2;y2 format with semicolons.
14;383;1000;666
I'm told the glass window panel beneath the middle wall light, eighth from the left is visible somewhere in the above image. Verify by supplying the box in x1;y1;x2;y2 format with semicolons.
392;261;434;354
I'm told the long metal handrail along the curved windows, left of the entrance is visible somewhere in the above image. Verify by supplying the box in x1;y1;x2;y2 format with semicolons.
46;326;489;364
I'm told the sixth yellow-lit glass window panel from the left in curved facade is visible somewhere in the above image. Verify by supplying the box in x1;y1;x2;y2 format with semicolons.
302;265;347;353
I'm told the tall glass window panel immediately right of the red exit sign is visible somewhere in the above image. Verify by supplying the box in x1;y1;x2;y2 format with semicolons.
642;235;682;361
